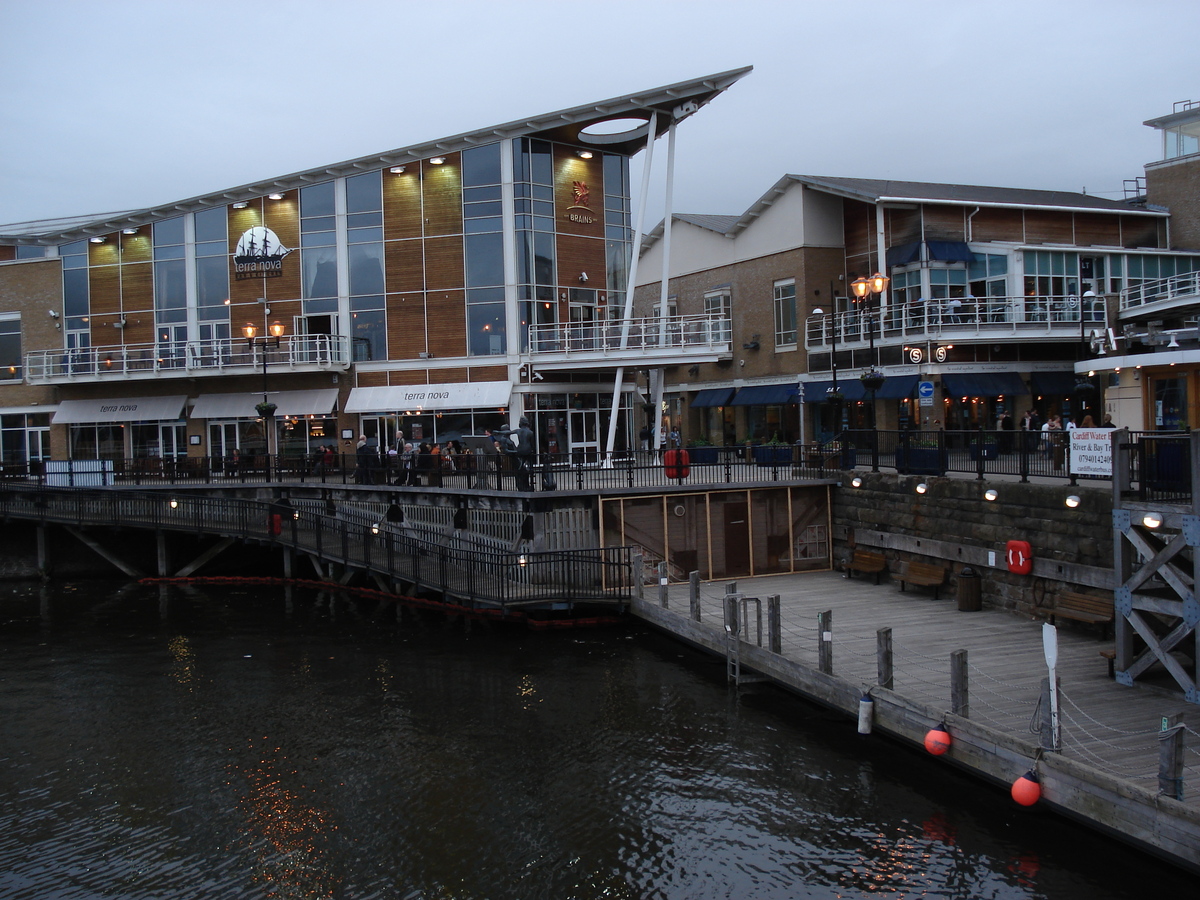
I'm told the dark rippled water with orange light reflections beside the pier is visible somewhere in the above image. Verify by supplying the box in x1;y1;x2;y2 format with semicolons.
0;584;1190;900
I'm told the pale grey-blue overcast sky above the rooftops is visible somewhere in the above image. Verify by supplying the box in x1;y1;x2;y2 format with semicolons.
0;0;1200;224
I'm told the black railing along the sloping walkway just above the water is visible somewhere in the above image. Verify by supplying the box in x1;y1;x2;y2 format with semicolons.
0;482;635;608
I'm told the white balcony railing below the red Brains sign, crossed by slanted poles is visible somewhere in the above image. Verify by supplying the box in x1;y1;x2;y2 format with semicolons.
529;316;733;356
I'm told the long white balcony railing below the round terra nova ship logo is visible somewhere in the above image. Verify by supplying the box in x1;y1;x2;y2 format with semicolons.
25;335;350;383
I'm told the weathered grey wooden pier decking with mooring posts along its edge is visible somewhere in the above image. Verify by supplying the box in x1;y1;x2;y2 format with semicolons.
634;571;1200;871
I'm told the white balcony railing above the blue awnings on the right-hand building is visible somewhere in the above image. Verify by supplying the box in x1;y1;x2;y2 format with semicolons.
804;295;1108;349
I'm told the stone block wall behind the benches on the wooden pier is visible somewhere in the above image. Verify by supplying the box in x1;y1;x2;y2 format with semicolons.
833;472;1112;614
